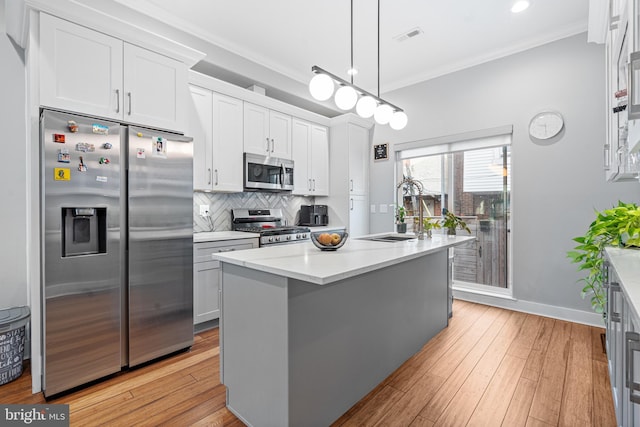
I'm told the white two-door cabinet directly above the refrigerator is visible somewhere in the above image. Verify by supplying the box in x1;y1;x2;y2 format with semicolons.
39;13;188;132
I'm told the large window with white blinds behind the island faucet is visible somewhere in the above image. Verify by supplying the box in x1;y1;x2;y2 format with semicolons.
396;127;511;289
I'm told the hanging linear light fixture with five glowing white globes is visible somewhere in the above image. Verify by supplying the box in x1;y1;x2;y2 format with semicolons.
309;0;408;130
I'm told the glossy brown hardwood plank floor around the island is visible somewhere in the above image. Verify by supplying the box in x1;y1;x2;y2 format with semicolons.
0;301;616;427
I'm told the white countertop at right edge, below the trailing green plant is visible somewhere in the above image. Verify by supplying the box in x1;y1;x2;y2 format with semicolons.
606;248;640;319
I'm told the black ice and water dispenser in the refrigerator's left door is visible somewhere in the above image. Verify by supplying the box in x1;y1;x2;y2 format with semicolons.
62;207;107;258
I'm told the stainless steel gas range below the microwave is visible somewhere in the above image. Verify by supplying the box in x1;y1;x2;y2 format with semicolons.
231;209;310;246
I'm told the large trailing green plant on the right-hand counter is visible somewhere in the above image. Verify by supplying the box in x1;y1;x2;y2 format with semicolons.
567;201;640;313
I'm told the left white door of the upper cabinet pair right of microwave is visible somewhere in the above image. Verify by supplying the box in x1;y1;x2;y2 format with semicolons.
291;119;313;195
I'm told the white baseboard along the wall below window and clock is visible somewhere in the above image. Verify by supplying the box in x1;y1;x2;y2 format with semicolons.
453;286;604;328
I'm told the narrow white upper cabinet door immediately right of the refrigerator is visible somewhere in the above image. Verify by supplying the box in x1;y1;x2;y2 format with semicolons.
188;86;214;191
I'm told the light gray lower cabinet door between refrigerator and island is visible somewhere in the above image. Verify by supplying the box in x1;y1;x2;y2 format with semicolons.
193;261;220;324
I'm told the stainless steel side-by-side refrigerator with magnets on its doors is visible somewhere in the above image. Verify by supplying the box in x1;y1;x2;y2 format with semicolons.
40;110;193;397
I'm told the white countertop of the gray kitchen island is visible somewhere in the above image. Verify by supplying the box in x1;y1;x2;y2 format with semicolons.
214;233;475;285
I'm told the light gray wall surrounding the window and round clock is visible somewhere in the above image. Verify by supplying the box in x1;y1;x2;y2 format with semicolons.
370;34;640;311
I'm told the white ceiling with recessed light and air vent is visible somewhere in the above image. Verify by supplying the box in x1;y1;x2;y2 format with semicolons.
115;0;589;99
